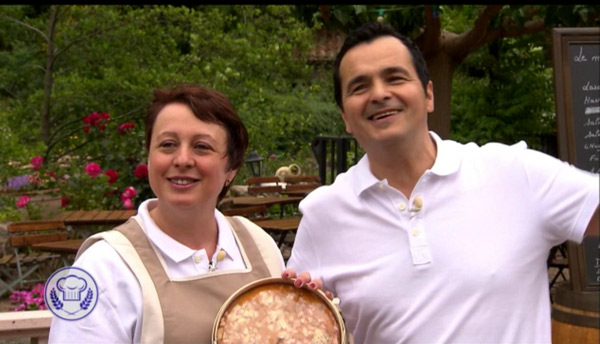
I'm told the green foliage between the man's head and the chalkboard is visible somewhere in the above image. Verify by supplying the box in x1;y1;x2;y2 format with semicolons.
452;35;555;149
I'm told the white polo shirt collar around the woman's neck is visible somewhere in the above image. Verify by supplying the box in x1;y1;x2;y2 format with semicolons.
138;198;237;263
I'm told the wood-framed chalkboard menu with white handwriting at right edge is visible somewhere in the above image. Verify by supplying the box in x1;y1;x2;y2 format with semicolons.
552;27;600;291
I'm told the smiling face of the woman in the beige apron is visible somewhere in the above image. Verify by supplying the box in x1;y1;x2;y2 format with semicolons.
148;103;235;209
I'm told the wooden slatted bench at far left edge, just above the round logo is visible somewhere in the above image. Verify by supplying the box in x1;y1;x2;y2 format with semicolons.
0;220;67;296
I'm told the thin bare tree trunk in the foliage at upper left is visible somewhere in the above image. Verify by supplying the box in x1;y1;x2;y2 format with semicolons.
41;5;57;145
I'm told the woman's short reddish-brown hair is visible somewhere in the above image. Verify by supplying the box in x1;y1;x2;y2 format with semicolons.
145;84;248;200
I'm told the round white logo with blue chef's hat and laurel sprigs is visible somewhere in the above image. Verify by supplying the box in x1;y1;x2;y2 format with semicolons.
44;266;98;320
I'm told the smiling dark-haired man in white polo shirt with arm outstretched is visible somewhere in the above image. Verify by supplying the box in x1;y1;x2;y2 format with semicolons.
283;23;599;344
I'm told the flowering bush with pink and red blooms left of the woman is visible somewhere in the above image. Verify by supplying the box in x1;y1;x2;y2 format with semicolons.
0;112;153;220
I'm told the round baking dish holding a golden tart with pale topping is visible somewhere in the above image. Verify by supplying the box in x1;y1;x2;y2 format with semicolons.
212;277;346;344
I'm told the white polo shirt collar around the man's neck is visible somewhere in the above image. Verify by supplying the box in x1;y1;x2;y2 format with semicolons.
353;131;461;196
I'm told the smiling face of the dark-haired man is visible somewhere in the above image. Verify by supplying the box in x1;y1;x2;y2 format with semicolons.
340;36;433;152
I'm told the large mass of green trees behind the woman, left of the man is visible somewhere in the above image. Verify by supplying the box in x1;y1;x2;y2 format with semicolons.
0;5;343;215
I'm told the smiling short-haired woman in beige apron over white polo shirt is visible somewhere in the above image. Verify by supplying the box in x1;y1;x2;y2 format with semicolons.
50;85;284;343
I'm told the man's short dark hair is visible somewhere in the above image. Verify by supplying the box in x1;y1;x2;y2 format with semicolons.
333;22;429;110
